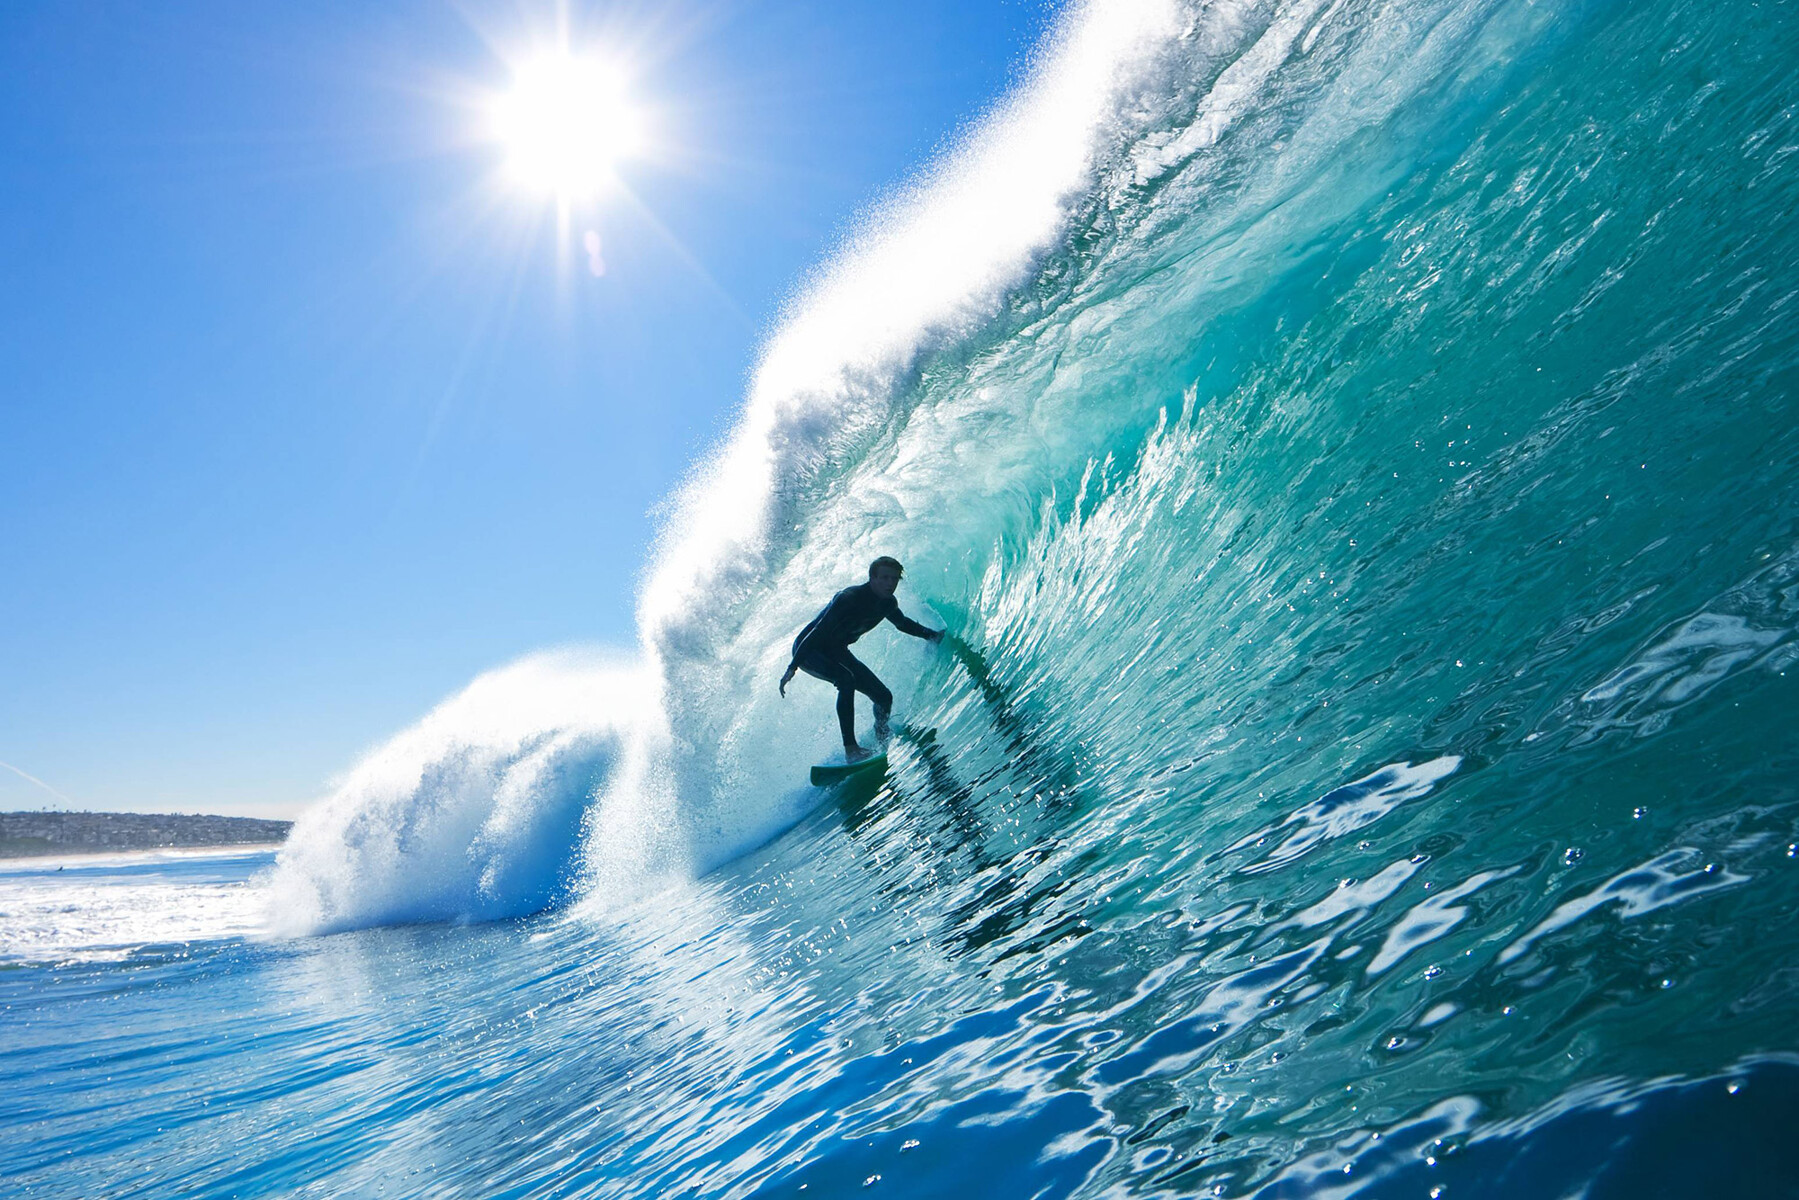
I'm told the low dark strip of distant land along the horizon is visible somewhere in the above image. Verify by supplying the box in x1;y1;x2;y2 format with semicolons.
0;811;293;862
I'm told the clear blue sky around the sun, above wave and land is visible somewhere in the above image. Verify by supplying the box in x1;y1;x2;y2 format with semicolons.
0;0;1051;815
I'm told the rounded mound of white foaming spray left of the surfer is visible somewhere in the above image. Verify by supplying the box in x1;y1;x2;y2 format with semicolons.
268;651;655;934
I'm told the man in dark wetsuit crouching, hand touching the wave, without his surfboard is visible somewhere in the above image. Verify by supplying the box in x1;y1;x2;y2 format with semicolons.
781;556;943;763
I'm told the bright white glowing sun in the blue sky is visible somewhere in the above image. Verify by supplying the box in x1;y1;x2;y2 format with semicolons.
489;52;644;203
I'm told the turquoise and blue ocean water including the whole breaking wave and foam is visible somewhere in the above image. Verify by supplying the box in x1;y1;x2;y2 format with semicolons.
0;0;1799;1200
